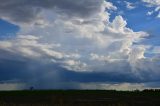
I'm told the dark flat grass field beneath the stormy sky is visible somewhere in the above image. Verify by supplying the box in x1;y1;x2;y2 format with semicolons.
0;90;160;106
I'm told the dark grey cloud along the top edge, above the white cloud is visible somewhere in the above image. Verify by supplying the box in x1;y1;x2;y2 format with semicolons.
0;0;104;22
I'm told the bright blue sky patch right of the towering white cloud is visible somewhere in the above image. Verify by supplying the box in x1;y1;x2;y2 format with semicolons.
110;0;160;45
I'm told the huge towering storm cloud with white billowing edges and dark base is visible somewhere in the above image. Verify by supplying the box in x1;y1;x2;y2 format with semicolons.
0;0;160;89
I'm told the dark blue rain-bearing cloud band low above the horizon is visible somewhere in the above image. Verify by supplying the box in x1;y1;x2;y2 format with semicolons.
0;50;157;89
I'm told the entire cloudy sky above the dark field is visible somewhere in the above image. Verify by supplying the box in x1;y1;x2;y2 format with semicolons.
0;0;160;90
